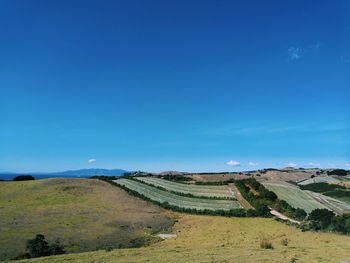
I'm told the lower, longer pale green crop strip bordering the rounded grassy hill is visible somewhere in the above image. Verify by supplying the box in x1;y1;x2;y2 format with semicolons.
114;179;240;210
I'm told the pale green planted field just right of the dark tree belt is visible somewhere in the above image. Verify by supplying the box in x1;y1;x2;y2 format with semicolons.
264;183;326;213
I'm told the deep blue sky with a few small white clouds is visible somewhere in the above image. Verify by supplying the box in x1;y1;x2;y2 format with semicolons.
0;0;350;172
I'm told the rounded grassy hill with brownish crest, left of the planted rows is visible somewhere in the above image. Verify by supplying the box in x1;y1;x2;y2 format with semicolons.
0;178;173;259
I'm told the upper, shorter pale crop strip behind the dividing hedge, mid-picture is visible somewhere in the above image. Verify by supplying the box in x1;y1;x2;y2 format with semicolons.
135;177;234;198
